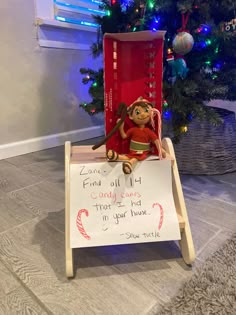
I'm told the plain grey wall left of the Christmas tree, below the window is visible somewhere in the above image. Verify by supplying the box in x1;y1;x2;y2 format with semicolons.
0;0;103;158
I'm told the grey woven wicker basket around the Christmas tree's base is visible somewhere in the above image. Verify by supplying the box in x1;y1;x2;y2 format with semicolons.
164;107;236;175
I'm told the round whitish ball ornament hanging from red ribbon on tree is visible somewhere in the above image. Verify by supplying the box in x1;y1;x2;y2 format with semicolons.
172;32;194;55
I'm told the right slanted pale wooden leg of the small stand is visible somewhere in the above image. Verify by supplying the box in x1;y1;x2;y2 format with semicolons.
162;138;195;265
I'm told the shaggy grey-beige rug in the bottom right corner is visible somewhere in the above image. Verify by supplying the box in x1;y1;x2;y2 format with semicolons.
156;234;236;315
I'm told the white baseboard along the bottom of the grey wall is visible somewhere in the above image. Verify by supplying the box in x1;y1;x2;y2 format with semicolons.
0;125;104;160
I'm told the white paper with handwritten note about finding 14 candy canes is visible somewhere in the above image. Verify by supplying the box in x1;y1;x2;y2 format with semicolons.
70;160;180;248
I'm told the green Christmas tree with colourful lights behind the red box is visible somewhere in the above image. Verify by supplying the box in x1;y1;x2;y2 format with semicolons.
81;0;236;141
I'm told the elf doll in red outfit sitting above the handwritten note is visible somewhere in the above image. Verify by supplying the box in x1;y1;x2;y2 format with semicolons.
106;97;170;174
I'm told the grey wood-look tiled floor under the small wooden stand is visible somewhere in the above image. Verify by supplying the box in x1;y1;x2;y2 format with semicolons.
0;139;236;315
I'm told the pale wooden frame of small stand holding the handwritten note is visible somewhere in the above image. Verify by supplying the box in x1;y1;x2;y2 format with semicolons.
65;138;195;278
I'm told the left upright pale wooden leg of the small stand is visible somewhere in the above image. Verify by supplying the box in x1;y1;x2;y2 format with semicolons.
65;141;74;278
